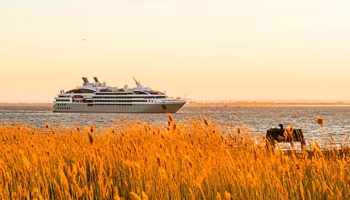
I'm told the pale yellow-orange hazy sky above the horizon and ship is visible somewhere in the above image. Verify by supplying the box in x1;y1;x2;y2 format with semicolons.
0;0;350;102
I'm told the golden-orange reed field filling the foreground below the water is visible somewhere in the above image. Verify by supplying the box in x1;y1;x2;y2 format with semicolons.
0;116;350;200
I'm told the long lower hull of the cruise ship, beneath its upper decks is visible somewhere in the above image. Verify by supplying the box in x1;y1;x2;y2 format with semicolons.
53;102;185;113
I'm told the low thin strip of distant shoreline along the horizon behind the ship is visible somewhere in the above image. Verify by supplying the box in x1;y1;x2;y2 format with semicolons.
0;101;350;111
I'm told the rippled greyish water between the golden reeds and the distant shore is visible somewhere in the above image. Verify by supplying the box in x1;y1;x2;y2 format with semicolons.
0;106;350;147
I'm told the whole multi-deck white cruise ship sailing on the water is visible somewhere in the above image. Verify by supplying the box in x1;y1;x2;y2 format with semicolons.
53;77;186;113
